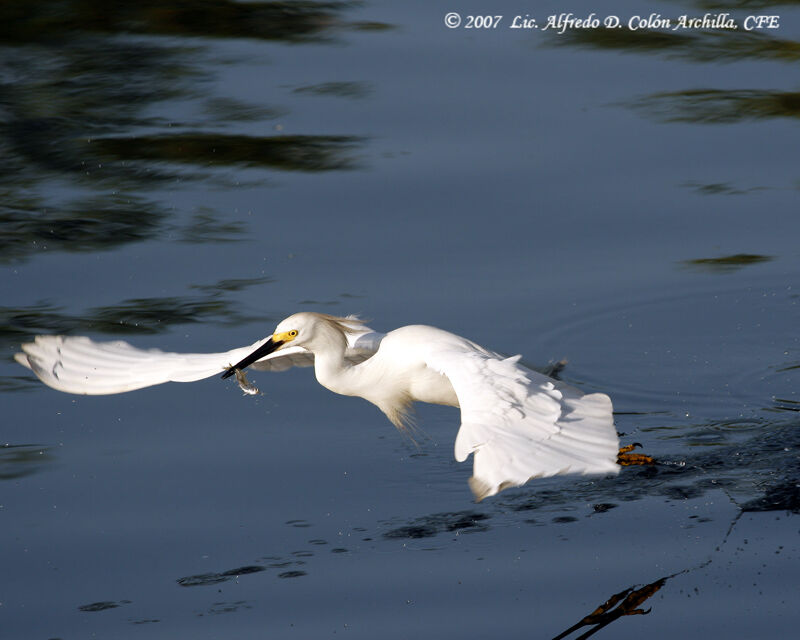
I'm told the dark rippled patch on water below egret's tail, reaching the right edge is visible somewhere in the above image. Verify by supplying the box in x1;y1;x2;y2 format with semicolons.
368;412;800;539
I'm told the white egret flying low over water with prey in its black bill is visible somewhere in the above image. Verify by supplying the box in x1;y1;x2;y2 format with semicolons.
15;312;619;500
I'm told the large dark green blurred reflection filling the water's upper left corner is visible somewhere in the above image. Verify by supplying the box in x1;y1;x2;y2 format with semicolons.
0;0;376;262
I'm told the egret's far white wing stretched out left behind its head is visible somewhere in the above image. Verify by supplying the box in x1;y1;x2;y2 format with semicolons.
14;330;382;395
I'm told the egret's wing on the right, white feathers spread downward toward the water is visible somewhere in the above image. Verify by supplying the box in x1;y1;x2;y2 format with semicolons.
426;339;619;500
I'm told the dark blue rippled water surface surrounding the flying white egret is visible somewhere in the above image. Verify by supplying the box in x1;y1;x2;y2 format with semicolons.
0;0;800;639
